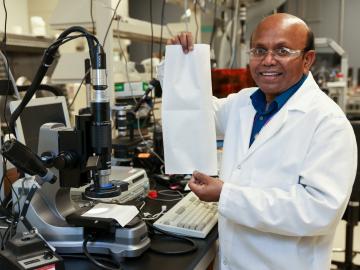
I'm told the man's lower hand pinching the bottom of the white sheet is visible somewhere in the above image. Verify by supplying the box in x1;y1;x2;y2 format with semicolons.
189;171;224;202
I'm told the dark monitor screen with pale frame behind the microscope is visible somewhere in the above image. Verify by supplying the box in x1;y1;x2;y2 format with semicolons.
10;96;70;153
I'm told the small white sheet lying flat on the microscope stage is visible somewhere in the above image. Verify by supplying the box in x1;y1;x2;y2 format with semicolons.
81;203;139;227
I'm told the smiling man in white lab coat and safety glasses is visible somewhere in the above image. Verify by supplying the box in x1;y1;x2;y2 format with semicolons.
169;14;357;270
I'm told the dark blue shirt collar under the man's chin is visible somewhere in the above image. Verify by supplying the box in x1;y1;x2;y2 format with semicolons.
250;74;307;114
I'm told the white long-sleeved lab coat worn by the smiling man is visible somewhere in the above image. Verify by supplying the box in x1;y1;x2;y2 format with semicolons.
214;73;357;270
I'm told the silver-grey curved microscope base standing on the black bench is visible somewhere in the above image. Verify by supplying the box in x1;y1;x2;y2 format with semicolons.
14;178;150;262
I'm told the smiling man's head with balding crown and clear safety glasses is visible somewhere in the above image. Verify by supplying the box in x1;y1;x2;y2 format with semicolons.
250;14;315;103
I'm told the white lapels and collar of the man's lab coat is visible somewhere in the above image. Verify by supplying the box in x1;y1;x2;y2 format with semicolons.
239;72;319;162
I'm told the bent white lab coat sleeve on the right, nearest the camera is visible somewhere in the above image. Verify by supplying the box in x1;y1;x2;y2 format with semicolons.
219;117;357;236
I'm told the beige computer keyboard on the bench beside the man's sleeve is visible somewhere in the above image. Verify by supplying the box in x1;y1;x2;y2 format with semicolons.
154;192;218;238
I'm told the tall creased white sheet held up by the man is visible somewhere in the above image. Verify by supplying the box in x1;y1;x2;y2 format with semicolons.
162;44;217;175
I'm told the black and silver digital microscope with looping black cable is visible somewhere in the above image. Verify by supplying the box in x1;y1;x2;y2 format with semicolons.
2;26;150;262
